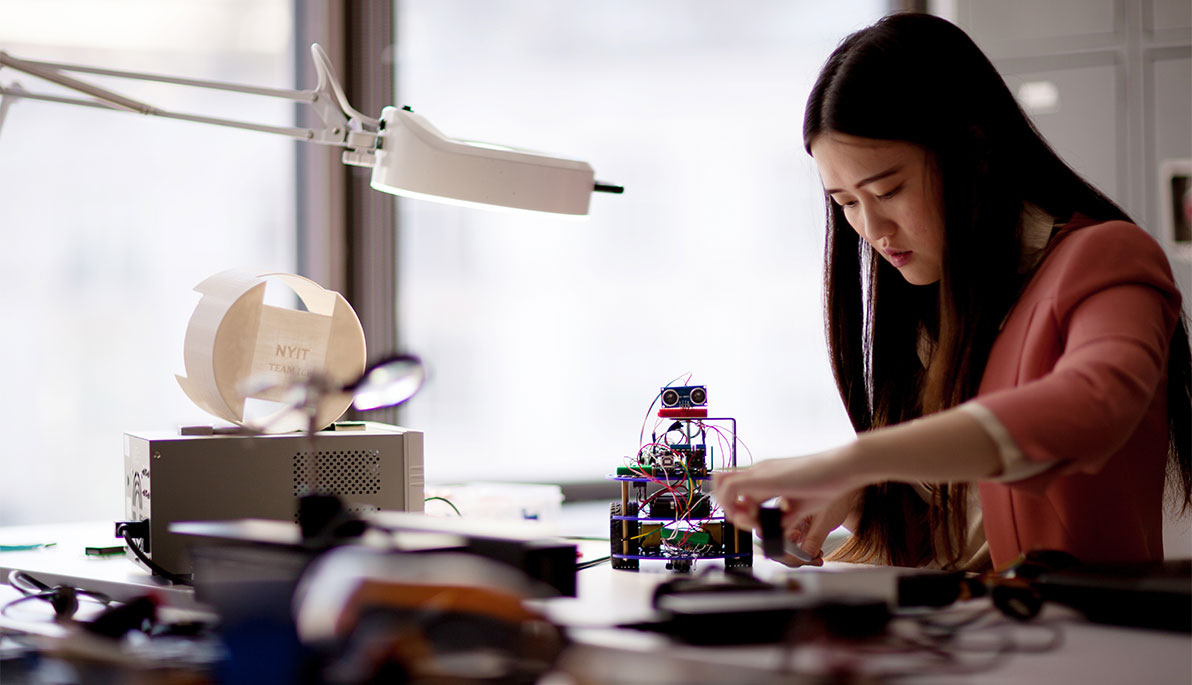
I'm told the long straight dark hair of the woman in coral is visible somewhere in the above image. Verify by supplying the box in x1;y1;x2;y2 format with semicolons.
803;13;1192;566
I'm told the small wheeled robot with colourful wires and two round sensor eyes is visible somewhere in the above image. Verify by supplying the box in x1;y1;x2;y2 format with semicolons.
609;385;753;572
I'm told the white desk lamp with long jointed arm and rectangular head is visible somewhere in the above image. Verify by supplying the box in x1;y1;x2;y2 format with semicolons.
0;43;623;217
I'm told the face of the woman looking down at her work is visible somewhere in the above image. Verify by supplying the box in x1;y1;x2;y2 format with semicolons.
812;131;944;286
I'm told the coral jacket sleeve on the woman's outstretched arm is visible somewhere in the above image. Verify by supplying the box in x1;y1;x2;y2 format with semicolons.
975;223;1180;478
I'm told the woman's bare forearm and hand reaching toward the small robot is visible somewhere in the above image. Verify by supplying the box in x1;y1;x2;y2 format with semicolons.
715;409;1001;531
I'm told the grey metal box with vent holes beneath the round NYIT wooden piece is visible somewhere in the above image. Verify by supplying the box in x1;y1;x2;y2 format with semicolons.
124;422;424;574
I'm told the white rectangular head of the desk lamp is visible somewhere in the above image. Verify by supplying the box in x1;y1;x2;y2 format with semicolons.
372;107;596;216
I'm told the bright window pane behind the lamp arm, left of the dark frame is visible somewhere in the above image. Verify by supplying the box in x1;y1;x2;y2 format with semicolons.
0;0;294;524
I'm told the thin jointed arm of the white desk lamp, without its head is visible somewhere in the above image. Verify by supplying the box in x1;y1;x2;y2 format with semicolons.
0;43;379;151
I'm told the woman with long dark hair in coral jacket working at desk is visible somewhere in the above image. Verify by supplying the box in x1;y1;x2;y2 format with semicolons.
716;14;1192;569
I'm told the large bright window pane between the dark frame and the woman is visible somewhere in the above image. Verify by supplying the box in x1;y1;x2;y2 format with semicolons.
397;5;886;482
